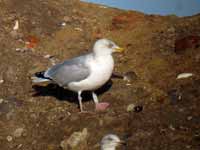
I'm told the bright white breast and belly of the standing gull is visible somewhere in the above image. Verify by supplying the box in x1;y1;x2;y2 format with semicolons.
68;55;114;91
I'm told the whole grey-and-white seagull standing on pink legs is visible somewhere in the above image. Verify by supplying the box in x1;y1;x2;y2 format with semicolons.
32;39;123;112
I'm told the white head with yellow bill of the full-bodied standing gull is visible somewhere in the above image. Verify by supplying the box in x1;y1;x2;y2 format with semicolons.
93;39;123;56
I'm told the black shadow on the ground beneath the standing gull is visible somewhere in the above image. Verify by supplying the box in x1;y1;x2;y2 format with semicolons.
32;79;113;104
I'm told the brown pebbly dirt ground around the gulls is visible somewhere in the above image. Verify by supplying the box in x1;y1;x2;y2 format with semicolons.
0;0;200;150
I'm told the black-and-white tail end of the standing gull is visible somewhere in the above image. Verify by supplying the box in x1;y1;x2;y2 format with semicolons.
31;71;51;83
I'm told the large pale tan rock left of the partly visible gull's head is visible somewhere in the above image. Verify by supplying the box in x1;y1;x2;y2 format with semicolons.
60;128;88;150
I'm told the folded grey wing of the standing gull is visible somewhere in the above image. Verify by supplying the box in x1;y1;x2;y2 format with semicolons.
45;55;90;86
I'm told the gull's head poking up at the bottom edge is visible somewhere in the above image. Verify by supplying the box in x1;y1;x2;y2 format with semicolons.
101;134;124;150
